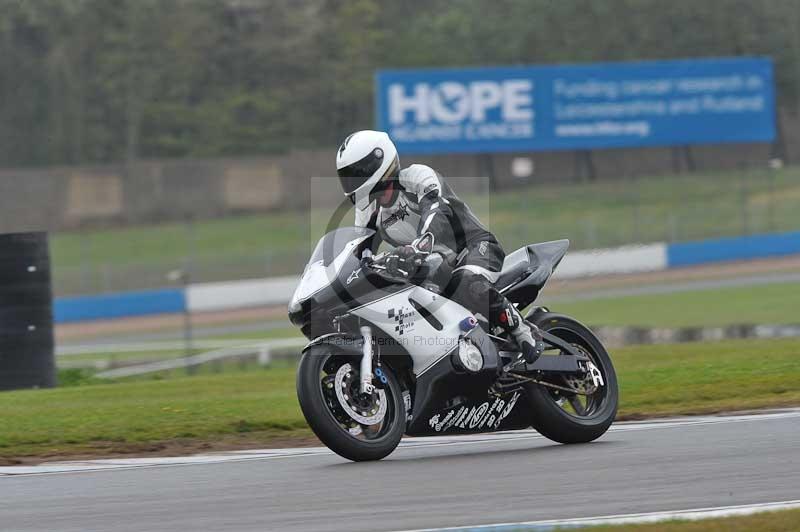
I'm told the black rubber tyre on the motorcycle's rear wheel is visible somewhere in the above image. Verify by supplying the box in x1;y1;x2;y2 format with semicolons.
526;313;619;443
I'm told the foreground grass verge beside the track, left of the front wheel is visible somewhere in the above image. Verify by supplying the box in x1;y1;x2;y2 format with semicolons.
0;368;306;456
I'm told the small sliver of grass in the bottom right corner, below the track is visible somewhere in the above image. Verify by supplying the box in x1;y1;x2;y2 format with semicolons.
580;510;800;532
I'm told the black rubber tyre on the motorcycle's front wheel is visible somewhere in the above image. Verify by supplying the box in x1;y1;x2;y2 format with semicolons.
297;345;406;462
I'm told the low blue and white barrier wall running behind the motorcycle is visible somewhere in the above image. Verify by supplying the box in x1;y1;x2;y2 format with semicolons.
54;232;800;323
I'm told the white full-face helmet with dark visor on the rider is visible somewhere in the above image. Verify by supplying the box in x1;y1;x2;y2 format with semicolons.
336;130;400;211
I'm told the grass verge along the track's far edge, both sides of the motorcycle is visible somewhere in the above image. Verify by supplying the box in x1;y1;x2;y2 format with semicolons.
0;339;800;457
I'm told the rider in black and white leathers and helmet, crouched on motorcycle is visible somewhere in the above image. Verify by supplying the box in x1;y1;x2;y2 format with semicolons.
336;130;543;362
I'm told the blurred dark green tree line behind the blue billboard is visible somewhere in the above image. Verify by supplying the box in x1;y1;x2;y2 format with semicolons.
0;0;800;167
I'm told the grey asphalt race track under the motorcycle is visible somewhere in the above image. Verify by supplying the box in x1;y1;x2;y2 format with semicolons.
0;410;800;532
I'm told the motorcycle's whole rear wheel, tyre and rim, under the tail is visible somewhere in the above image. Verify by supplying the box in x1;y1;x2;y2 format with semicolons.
526;313;619;443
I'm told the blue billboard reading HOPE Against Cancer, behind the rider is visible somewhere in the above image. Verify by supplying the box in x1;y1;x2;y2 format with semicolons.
376;57;775;153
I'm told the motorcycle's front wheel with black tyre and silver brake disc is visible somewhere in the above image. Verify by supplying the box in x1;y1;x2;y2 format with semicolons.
297;345;406;462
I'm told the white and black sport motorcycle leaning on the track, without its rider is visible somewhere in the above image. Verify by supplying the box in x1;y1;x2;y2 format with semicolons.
289;227;618;461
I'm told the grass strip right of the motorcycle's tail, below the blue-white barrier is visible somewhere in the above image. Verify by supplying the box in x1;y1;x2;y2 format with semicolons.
552;283;800;327
